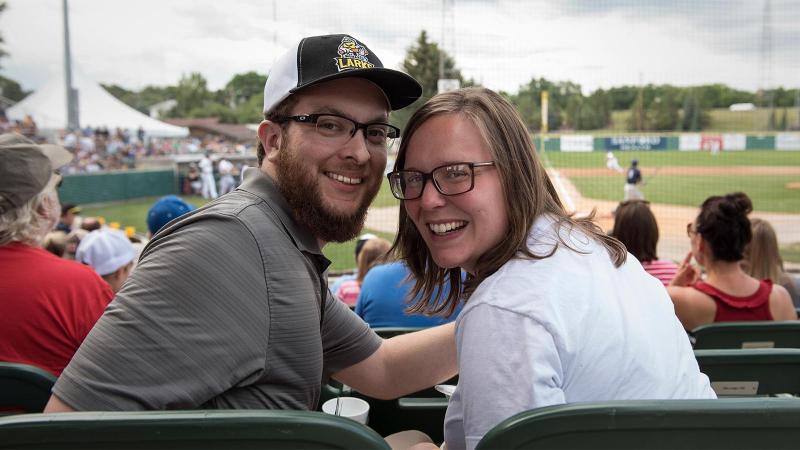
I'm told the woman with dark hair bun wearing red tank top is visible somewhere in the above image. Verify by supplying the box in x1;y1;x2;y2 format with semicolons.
667;192;797;330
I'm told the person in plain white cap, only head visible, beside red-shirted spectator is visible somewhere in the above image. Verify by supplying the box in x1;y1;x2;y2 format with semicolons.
75;228;136;292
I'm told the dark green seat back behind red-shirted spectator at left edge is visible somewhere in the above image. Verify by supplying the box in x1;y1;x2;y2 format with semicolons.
0;362;56;415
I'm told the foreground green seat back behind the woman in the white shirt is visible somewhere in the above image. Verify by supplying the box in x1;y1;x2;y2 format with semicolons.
477;398;800;450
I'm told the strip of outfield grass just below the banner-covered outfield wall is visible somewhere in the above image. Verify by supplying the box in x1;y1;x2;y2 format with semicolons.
544;150;800;169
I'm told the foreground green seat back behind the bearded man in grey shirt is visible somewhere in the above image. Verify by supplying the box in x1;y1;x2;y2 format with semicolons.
0;411;389;450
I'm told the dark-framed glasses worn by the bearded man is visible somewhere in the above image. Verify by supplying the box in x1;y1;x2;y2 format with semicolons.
277;114;400;149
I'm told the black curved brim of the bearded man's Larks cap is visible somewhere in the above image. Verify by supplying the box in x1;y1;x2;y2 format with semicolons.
289;67;422;111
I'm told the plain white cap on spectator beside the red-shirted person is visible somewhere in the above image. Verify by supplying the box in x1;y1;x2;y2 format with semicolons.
75;228;135;275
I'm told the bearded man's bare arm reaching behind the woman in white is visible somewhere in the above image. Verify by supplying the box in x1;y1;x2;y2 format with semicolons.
333;323;458;399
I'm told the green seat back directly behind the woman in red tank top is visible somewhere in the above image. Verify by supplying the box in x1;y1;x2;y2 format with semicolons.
691;320;800;350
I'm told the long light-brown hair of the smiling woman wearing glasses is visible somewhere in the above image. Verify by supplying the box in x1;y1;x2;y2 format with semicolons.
393;88;627;315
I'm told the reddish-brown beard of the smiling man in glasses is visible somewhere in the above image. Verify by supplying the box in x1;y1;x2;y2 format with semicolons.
275;143;380;242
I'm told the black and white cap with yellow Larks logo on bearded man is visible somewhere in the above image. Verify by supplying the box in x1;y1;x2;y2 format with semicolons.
264;34;422;113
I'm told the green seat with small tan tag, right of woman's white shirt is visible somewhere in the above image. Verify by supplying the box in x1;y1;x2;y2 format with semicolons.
694;348;800;397
